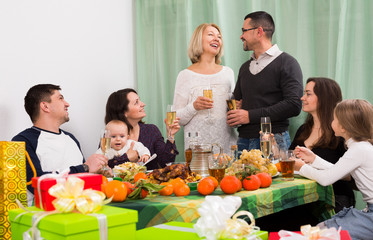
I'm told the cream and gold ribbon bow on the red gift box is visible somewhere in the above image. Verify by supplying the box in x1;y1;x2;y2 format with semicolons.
48;176;111;214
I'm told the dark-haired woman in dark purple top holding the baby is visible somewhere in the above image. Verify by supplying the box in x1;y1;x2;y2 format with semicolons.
105;88;180;170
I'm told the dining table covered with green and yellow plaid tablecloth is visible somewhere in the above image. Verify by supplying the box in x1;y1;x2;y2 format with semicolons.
109;176;334;230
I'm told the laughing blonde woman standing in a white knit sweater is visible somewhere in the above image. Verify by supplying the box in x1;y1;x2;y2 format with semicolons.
173;23;237;152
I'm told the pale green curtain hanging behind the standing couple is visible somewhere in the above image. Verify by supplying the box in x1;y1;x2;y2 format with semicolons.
135;0;373;161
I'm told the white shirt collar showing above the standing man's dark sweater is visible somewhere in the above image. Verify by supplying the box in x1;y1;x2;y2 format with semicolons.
250;44;282;75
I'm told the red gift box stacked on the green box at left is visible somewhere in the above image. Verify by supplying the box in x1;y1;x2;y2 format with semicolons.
32;173;102;211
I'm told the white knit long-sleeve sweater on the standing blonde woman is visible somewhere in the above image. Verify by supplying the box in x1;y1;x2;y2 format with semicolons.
173;66;237;153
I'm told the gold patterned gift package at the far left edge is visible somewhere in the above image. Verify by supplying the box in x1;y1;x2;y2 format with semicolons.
0;141;27;239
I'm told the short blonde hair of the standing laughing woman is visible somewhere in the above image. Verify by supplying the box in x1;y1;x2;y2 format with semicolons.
188;23;224;64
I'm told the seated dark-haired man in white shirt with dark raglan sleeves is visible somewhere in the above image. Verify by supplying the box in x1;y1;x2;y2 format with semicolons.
12;84;107;205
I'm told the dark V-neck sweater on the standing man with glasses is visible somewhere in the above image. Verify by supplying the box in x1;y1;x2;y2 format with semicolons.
234;52;303;138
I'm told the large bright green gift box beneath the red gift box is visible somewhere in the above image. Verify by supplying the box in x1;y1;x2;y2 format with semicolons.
9;206;138;240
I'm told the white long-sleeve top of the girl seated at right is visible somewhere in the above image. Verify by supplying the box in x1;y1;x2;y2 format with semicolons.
299;138;373;203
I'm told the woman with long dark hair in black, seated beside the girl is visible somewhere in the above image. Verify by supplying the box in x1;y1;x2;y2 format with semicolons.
290;78;355;212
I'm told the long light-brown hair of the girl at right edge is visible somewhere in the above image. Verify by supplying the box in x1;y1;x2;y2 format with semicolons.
334;99;373;145
